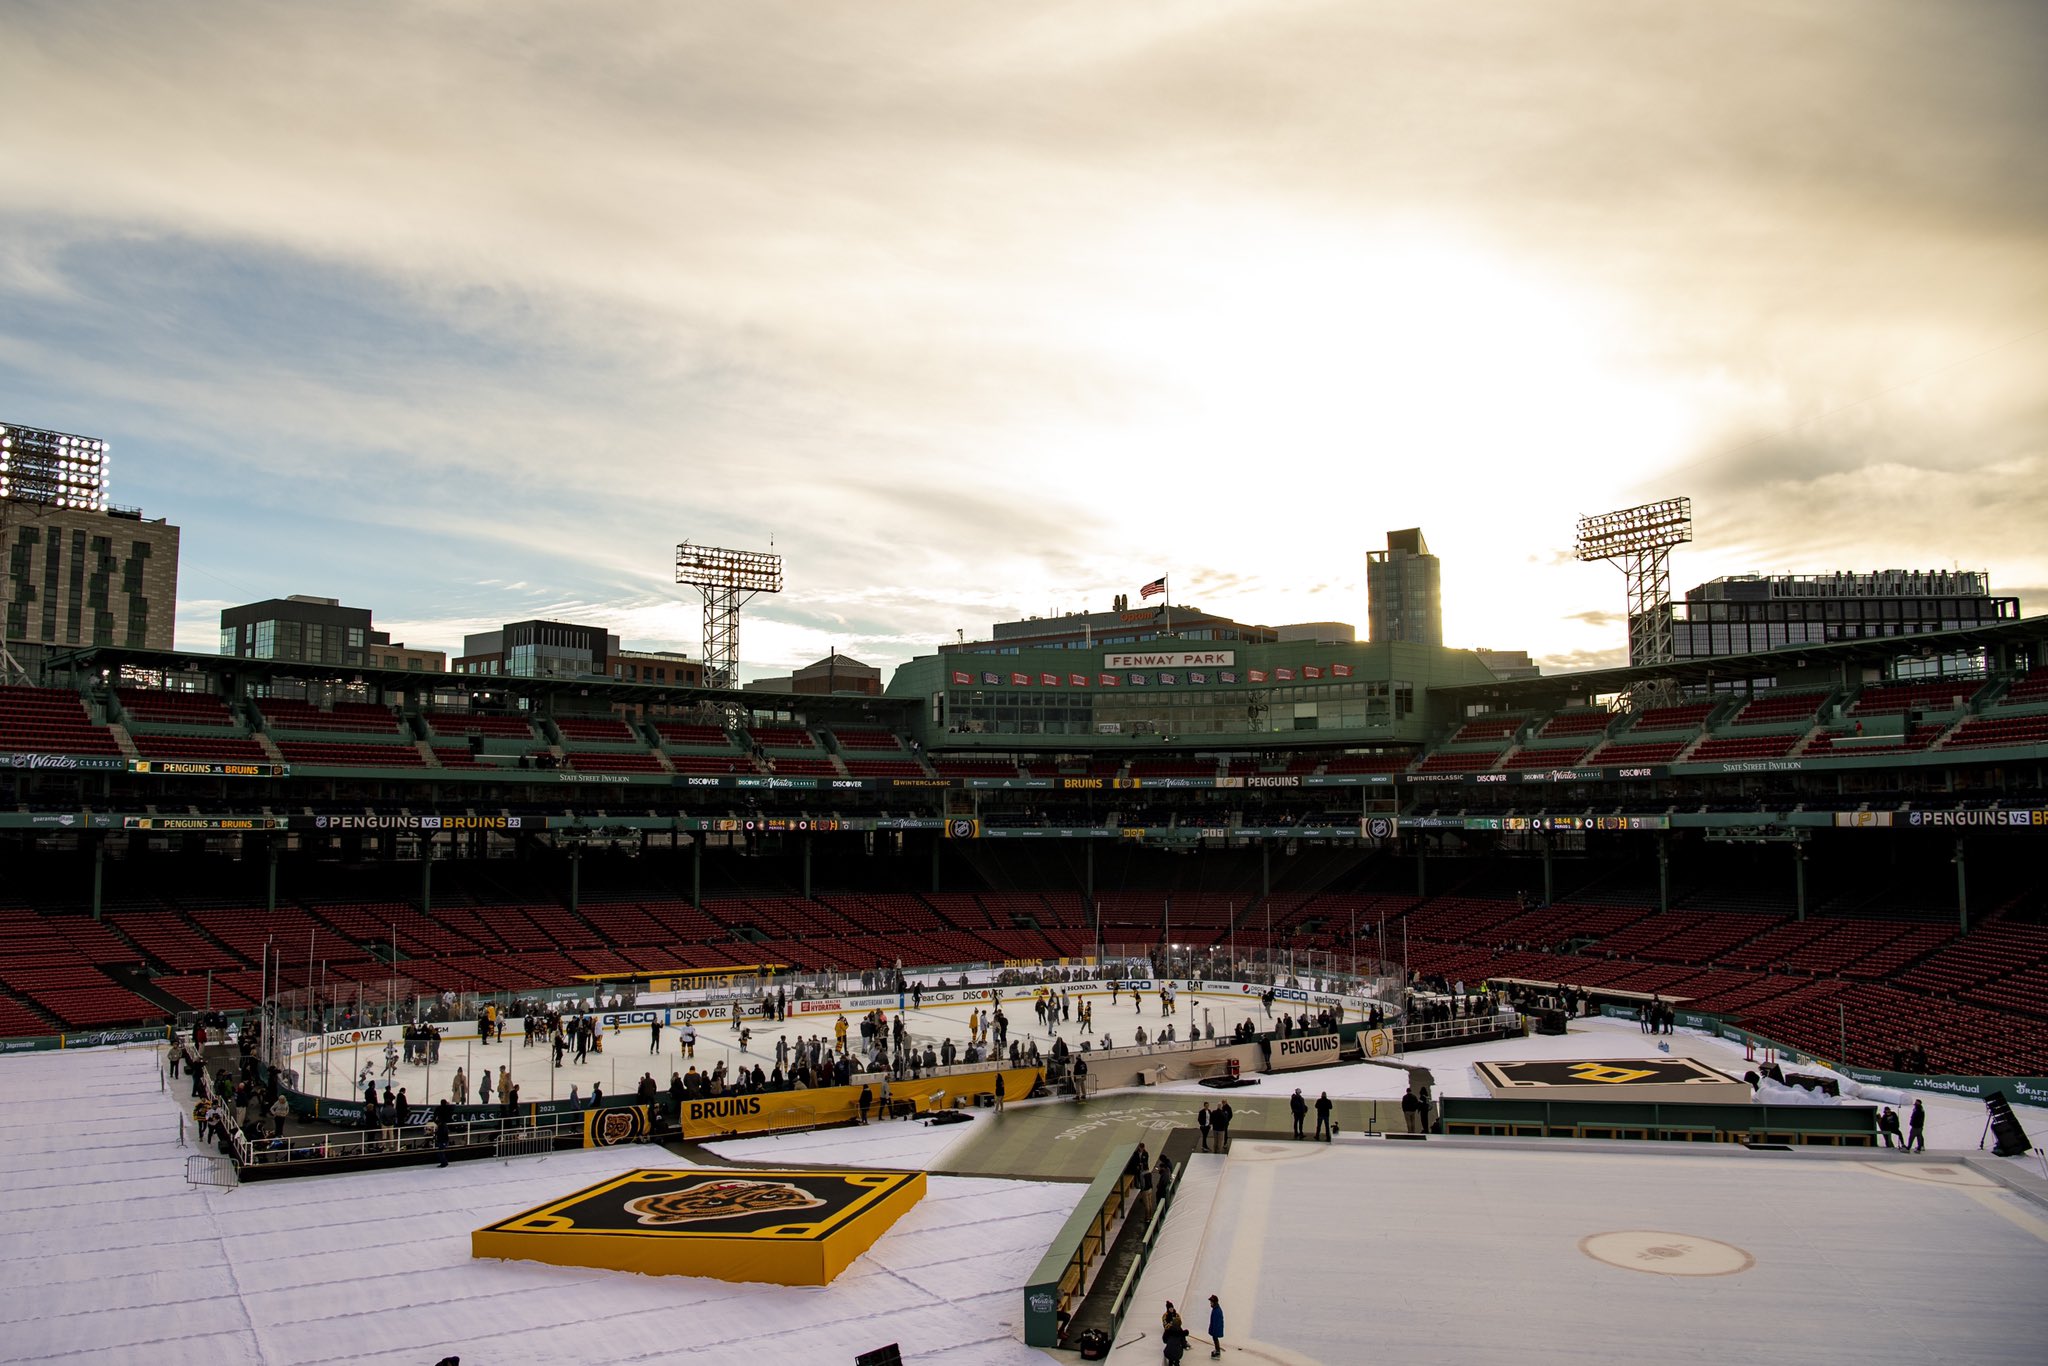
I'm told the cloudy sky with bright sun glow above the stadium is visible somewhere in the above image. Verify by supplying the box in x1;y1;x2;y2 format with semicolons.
0;0;2048;678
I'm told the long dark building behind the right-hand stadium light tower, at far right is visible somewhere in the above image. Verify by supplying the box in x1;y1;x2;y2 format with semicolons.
1671;569;2019;672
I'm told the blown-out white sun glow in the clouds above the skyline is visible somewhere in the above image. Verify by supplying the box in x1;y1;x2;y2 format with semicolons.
1040;213;1698;645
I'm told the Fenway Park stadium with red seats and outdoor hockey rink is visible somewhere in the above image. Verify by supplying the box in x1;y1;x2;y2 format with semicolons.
0;520;2048;1362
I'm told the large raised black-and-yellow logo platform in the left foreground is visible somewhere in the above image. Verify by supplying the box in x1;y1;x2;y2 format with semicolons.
469;1163;926;1286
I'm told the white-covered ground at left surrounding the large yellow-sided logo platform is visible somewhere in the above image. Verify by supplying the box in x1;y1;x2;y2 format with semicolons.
0;1049;1081;1366
